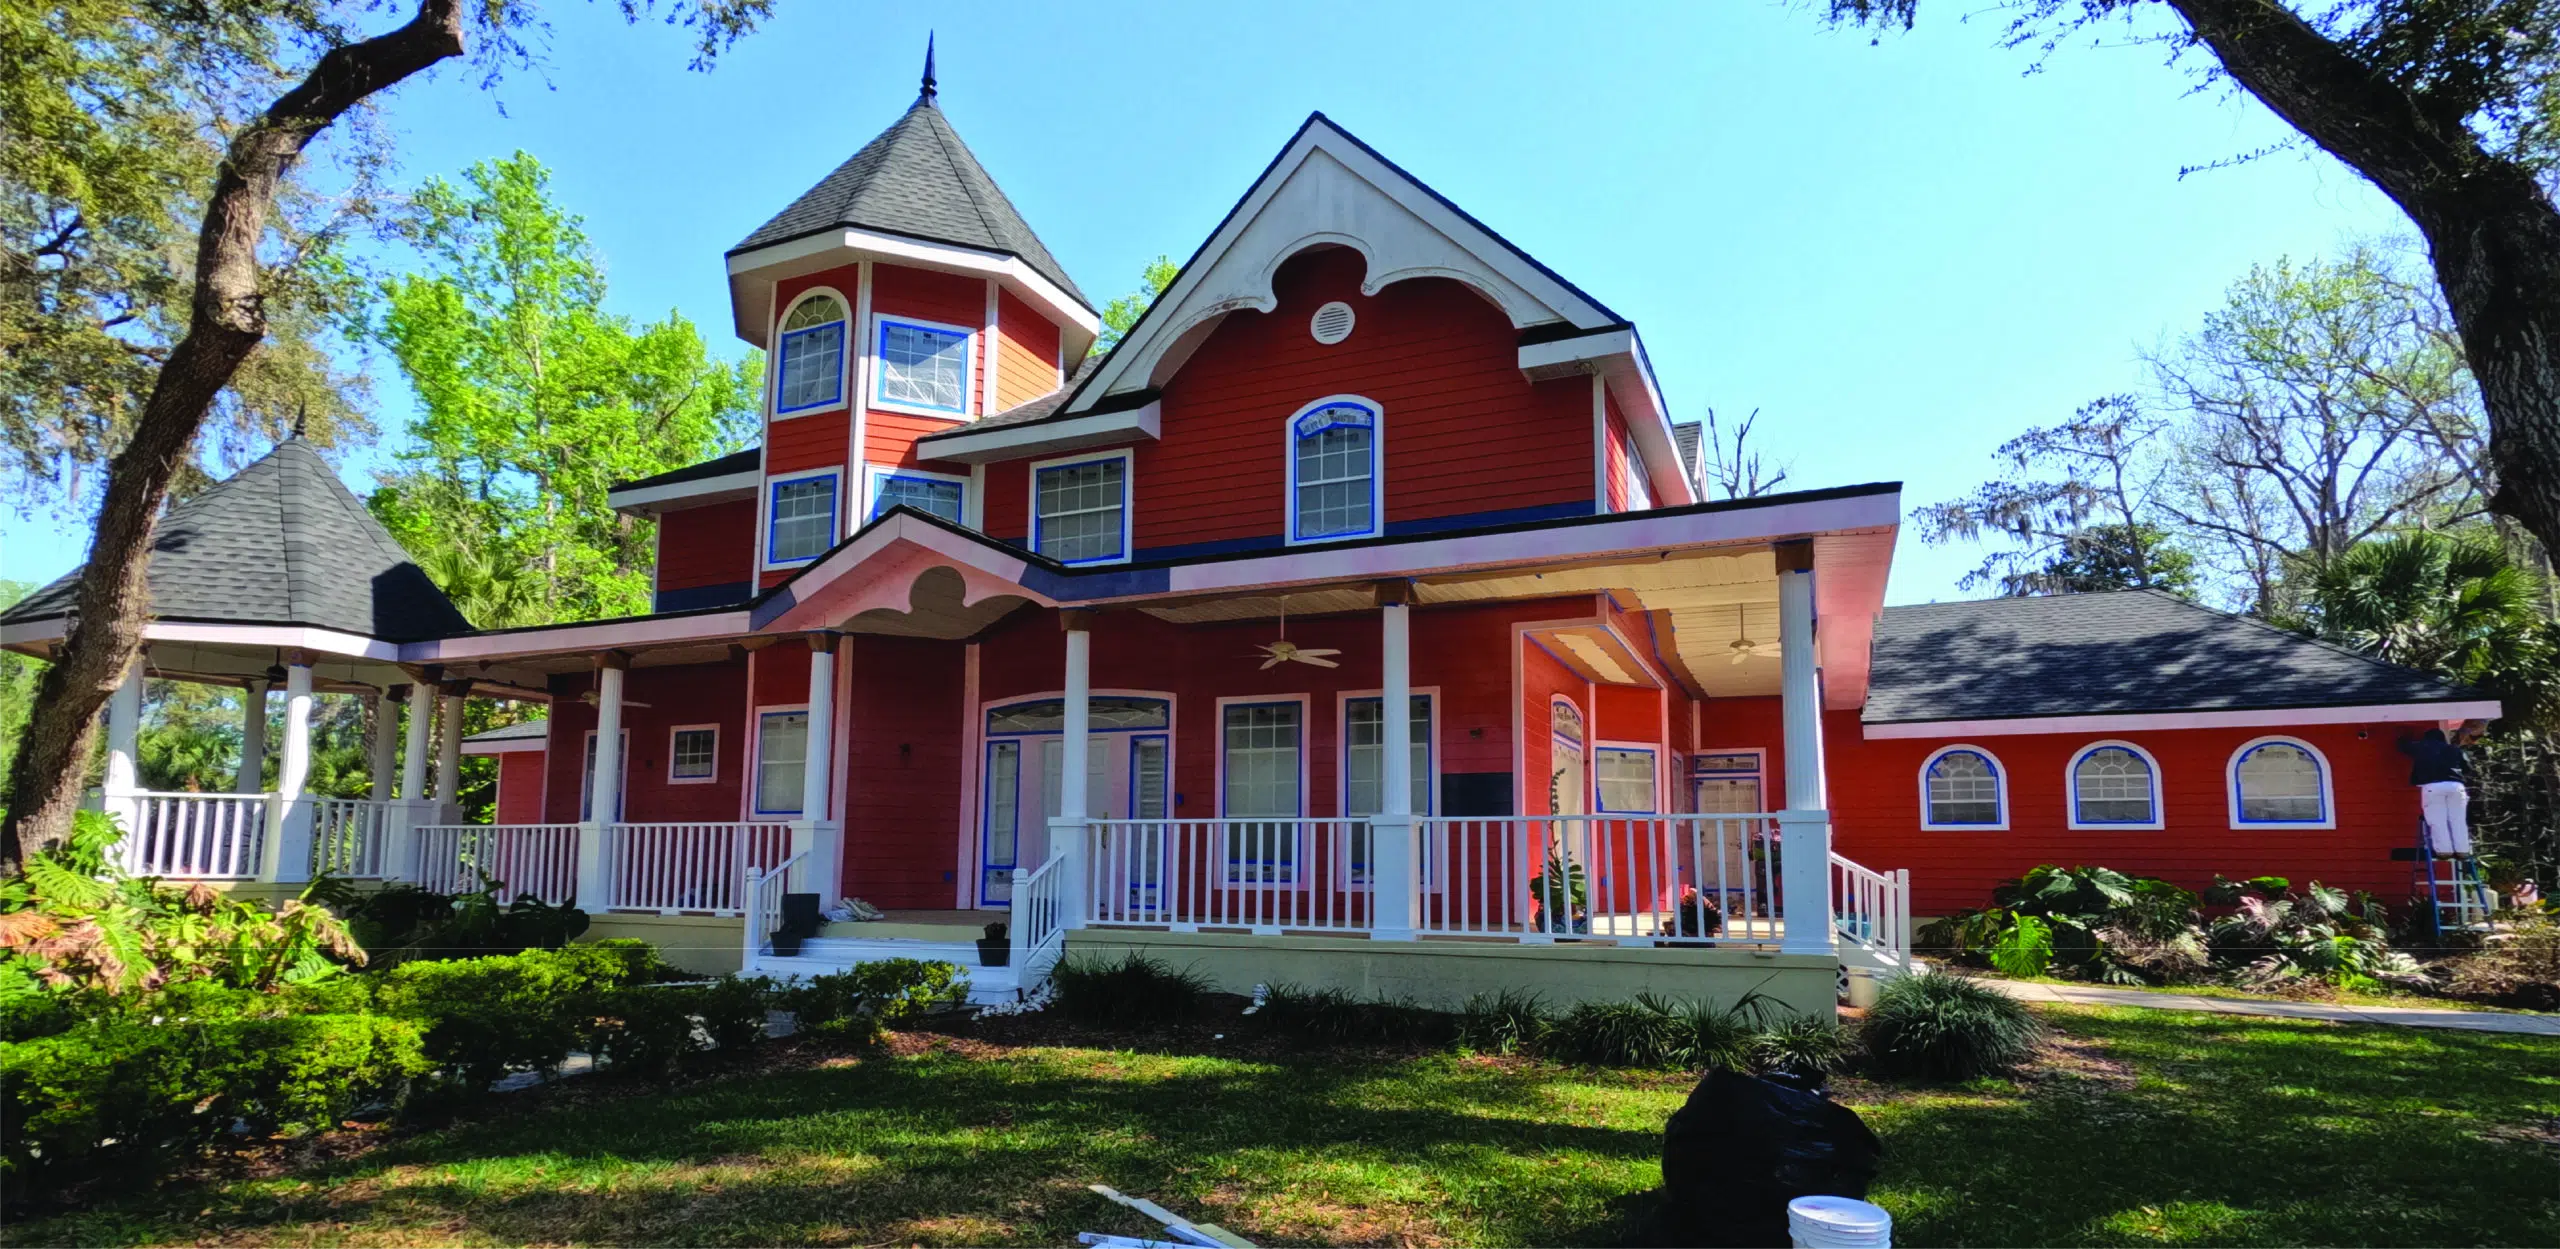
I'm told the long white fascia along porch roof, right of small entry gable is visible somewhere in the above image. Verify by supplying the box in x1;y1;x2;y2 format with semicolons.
1141;491;1902;601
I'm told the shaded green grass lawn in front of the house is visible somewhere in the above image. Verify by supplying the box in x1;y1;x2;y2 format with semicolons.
20;1008;2560;1244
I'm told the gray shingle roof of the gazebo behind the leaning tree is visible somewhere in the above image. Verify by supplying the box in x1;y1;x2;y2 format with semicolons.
0;440;471;642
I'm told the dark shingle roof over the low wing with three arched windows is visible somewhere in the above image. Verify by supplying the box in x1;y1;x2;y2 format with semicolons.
1864;589;2478;724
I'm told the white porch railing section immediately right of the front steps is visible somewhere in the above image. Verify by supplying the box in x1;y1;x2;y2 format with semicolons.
1085;819;1377;932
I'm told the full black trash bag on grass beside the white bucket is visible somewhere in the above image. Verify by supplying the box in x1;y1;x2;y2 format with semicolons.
1661;1070;1884;1246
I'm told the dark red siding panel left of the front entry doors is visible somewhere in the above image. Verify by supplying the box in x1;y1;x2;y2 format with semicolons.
842;635;965;906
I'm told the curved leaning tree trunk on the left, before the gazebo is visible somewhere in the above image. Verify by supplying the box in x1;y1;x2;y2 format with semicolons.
0;0;463;873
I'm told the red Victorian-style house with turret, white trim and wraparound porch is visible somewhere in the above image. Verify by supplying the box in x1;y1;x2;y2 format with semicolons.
0;68;2496;1008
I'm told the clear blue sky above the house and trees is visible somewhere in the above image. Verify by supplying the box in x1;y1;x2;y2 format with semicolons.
0;0;2401;601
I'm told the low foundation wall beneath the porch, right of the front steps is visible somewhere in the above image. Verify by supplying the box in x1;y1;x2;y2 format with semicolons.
1068;929;1838;1019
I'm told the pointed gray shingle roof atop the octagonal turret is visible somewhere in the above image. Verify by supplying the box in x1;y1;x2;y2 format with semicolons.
730;95;1093;307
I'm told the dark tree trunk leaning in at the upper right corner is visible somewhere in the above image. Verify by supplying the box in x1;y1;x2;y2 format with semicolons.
2168;0;2560;550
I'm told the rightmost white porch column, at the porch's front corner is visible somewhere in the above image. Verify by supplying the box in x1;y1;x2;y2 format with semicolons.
1777;543;1833;955
